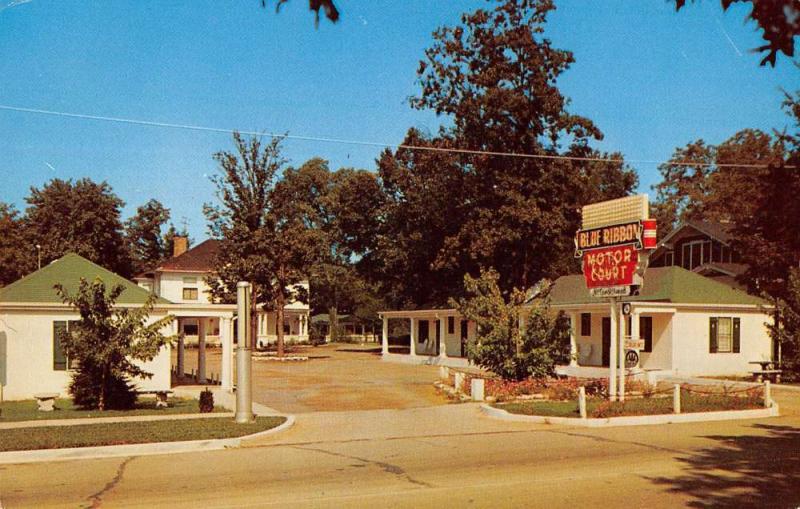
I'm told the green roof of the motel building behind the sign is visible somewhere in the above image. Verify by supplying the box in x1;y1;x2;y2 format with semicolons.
550;266;767;305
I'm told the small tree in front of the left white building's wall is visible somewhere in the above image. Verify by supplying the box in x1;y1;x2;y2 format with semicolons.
55;278;173;411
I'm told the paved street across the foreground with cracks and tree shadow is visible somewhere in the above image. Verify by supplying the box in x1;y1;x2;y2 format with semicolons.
0;386;800;508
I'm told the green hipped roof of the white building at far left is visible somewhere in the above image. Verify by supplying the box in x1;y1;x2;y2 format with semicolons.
0;253;170;304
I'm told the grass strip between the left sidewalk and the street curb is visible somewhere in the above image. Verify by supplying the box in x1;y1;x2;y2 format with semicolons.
0;417;286;451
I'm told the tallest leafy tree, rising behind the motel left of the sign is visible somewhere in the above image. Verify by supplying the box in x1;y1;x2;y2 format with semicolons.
374;0;636;305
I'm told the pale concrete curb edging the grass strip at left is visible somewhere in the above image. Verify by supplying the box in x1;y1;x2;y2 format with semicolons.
0;415;295;465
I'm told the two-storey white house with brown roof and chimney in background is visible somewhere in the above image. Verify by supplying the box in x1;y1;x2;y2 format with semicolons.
134;237;310;346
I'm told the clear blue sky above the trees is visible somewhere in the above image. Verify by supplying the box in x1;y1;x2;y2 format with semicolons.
0;0;800;240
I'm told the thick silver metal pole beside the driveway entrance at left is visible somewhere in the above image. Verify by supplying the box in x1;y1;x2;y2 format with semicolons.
236;281;253;423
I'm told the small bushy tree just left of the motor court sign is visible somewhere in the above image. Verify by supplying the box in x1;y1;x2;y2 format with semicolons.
454;269;569;380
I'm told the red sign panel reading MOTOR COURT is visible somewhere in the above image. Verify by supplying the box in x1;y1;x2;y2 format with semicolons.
583;244;639;288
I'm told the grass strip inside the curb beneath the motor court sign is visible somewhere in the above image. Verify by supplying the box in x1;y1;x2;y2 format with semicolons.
496;393;763;417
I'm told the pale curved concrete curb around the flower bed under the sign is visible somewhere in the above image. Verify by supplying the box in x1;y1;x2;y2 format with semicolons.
481;402;780;428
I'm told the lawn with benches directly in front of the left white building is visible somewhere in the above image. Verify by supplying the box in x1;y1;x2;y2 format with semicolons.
0;398;226;422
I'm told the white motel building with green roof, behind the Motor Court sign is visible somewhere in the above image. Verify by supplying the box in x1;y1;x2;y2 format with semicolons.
379;266;774;377
